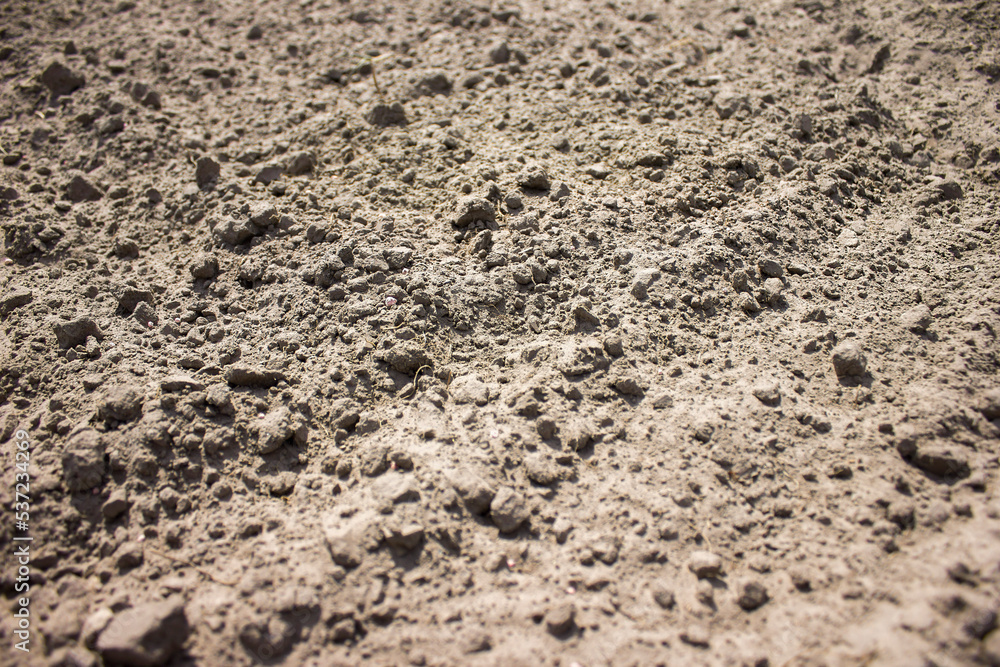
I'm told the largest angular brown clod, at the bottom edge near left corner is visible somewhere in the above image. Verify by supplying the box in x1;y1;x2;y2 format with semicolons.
97;600;190;667
